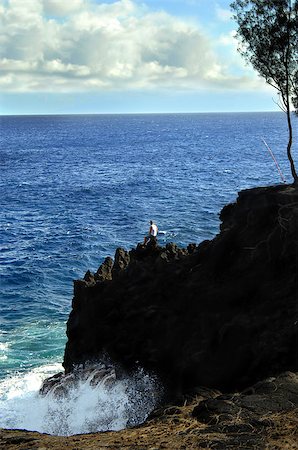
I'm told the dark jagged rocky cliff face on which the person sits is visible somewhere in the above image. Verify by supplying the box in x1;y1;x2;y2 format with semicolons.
64;186;298;395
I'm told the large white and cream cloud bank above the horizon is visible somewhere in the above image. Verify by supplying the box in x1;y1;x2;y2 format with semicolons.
0;0;258;92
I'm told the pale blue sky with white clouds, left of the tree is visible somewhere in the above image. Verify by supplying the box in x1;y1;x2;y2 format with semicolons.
0;0;278;115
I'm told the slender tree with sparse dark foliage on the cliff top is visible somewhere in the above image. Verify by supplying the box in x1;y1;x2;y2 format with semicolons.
231;0;298;184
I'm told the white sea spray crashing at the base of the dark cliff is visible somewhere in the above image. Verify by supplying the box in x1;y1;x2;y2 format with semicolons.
0;365;162;436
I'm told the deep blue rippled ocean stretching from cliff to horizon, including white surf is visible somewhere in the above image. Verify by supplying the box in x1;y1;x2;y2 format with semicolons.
0;112;297;434
